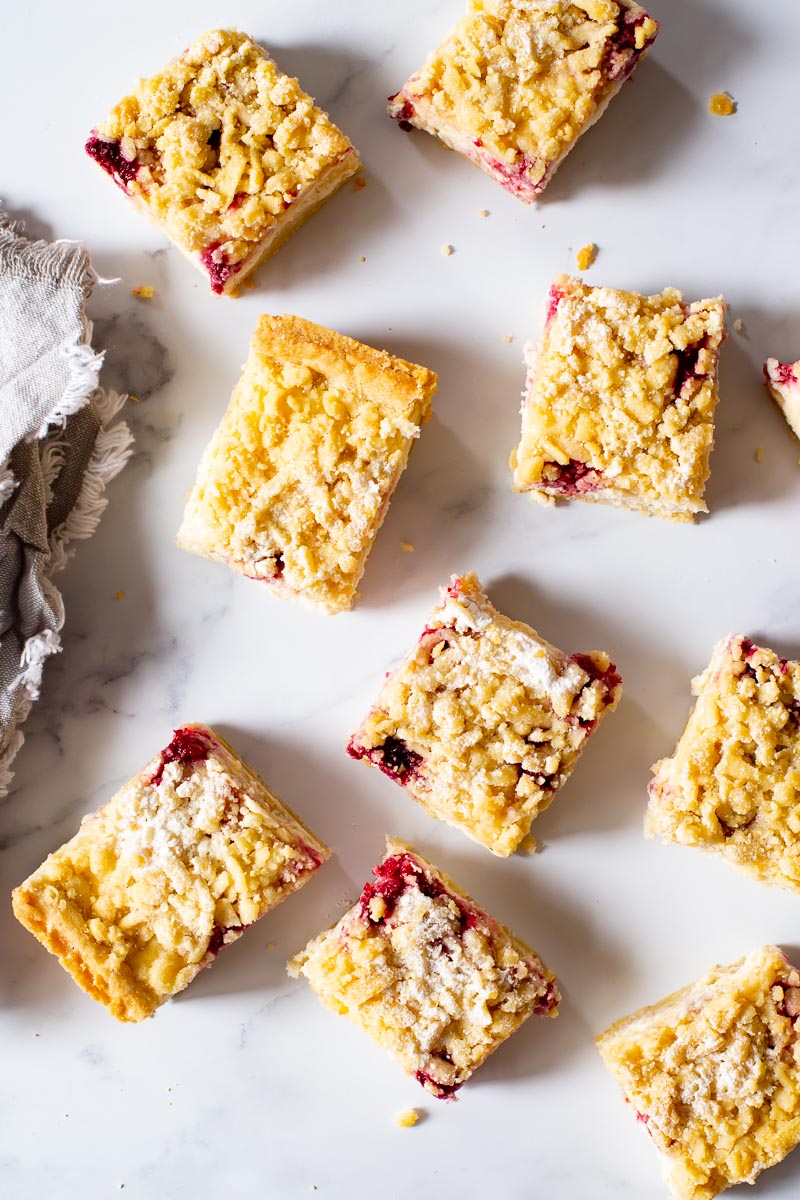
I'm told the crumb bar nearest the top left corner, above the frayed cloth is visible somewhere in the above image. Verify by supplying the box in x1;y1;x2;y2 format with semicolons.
86;29;360;295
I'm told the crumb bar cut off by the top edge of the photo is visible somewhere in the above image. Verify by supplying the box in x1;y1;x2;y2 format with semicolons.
389;0;658;204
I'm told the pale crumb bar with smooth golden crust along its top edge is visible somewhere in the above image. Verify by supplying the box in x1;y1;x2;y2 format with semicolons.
178;316;437;613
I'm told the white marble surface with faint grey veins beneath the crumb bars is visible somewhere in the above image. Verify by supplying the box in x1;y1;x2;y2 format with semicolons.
0;0;800;1200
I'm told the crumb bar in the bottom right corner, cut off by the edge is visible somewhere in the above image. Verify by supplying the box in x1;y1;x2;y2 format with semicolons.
597;946;800;1200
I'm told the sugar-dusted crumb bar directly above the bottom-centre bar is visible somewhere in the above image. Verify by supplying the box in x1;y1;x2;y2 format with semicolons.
348;574;622;857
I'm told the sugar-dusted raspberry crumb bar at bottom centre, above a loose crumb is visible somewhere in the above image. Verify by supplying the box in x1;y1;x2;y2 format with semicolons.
289;840;560;1099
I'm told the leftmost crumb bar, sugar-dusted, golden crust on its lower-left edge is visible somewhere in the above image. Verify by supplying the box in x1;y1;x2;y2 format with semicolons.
13;725;330;1021
